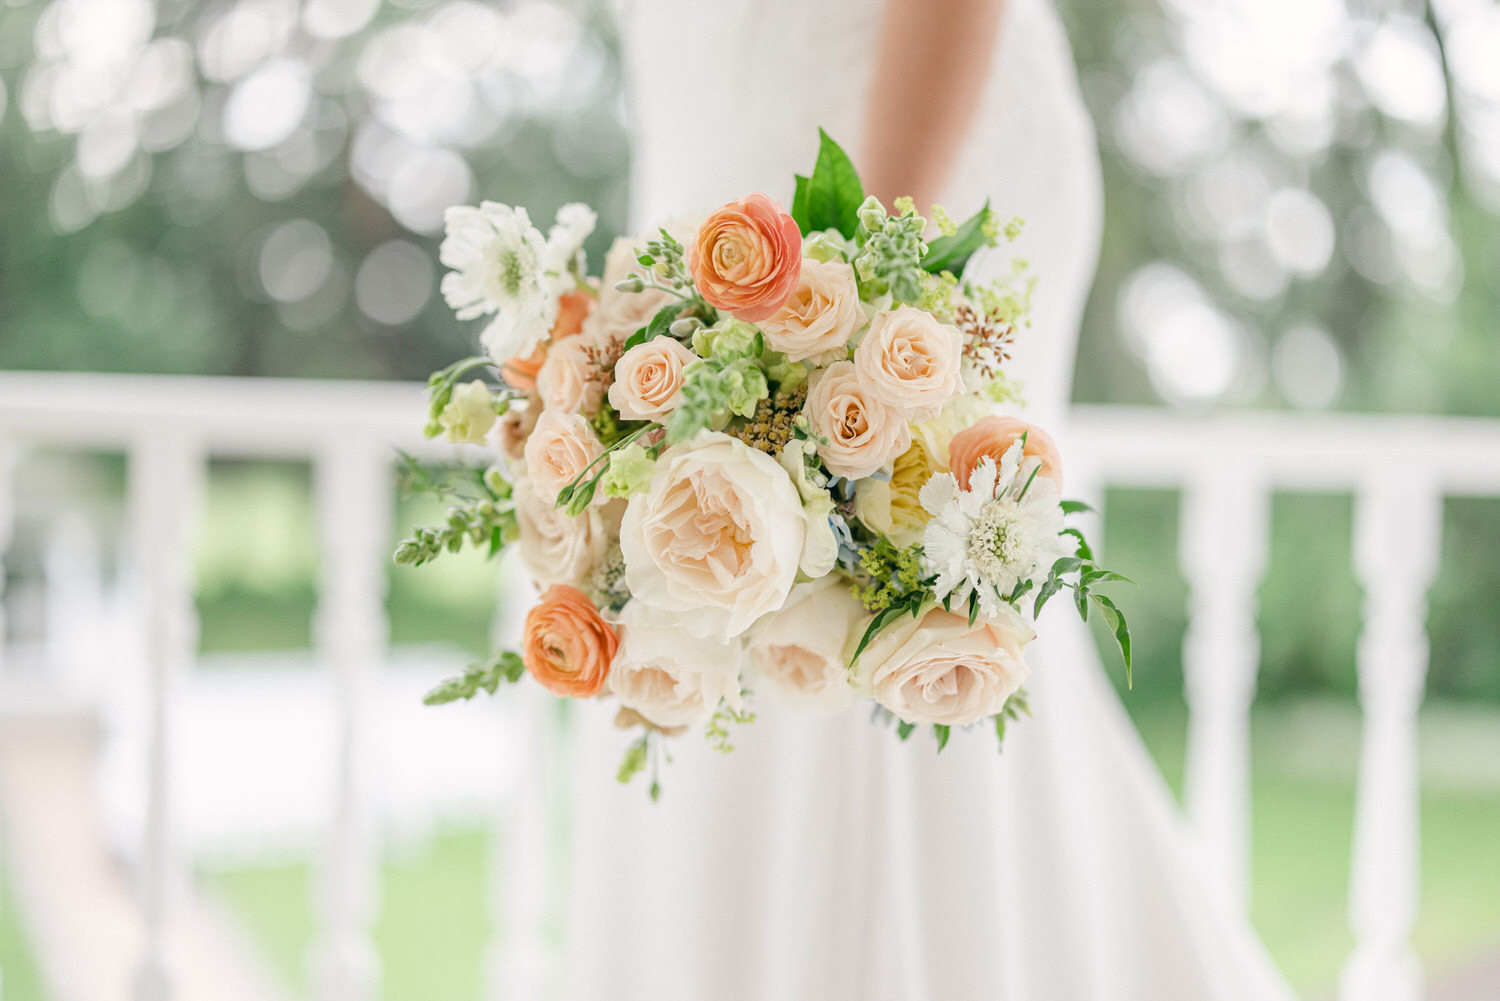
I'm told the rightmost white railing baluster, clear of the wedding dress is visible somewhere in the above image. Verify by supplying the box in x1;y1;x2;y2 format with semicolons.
1340;474;1443;1001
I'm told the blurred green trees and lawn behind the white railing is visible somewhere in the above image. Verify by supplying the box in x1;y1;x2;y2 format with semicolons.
0;0;1500;1001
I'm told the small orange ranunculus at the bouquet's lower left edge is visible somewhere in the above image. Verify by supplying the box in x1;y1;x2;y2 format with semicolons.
521;584;620;698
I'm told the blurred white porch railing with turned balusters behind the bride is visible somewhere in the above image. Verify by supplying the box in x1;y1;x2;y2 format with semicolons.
0;374;1500;1001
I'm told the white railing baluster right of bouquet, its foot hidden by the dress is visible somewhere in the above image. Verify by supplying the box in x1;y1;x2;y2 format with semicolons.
1179;461;1271;911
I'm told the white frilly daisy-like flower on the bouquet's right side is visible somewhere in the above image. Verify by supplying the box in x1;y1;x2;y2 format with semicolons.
920;441;1073;618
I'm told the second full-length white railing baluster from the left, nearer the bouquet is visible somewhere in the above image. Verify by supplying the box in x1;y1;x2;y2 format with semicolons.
312;438;395;1001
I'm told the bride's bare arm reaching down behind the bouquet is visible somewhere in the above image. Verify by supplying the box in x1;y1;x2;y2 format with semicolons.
860;0;1005;210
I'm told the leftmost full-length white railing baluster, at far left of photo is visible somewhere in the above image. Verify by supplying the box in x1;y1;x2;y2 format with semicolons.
129;428;203;1001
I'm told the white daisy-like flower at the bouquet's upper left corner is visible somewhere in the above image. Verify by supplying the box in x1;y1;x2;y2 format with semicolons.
438;201;570;363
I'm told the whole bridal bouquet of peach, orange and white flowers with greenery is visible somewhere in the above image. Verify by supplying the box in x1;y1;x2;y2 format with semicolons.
396;135;1130;795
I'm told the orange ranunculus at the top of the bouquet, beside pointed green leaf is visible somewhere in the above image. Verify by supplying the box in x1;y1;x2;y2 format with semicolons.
687;192;803;323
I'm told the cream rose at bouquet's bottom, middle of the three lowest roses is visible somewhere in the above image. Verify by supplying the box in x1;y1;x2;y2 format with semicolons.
750;573;869;713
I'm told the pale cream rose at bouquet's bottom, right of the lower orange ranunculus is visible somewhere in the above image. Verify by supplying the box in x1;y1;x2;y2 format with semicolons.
609;600;744;728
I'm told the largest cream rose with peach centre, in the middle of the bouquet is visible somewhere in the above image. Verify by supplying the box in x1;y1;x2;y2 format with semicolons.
620;431;804;639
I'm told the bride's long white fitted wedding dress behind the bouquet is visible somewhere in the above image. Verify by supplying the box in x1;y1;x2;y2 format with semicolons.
566;0;1292;1001
